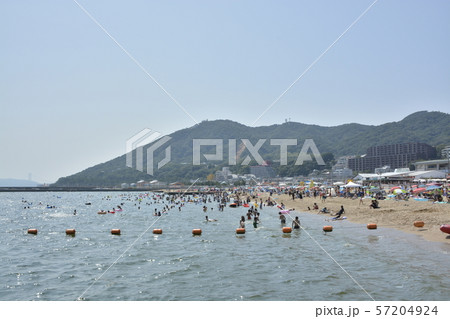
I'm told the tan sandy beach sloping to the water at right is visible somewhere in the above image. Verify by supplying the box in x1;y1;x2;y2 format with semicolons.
272;195;450;244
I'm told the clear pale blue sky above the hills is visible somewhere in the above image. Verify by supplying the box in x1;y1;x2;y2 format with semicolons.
0;0;450;183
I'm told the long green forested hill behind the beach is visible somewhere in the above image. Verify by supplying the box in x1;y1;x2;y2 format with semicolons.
52;111;450;187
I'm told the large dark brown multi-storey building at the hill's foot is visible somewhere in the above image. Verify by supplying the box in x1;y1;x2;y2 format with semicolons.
348;143;436;172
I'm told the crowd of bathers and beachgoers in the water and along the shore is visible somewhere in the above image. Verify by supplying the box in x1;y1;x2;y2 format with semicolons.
17;181;449;239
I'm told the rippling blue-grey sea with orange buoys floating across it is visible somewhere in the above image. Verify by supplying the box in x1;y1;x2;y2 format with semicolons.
0;192;450;301
